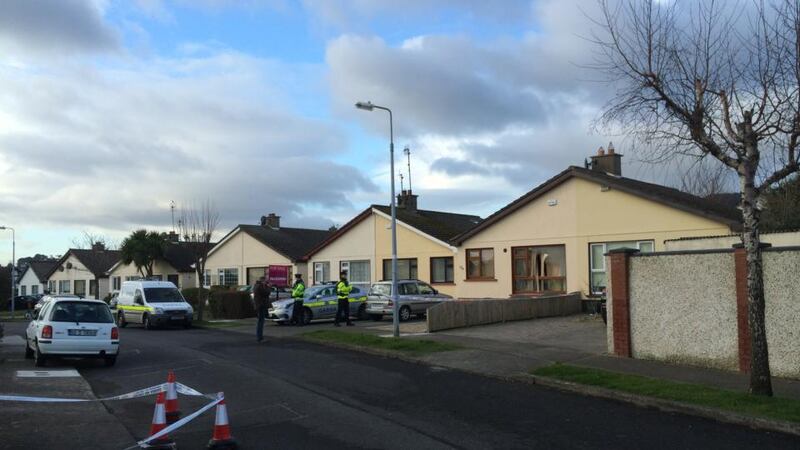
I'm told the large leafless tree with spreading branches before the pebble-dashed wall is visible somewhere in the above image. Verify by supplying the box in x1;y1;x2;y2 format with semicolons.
593;0;800;395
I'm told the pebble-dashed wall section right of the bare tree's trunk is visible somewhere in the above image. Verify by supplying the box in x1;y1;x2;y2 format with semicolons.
763;250;800;378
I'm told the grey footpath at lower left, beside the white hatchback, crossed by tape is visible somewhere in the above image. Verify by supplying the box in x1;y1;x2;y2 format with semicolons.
0;322;135;449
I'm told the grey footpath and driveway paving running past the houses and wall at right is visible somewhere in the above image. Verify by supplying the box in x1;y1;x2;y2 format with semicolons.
216;315;800;436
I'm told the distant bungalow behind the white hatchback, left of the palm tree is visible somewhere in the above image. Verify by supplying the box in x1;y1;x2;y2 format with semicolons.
47;243;120;299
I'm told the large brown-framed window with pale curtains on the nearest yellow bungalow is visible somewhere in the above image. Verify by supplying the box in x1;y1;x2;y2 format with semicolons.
511;245;567;294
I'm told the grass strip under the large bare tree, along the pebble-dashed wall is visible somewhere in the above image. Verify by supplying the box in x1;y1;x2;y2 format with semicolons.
531;364;800;423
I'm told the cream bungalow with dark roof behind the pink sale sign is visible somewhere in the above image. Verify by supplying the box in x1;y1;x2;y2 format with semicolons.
203;213;331;286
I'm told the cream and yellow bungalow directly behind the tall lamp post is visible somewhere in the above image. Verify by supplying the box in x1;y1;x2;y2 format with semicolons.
307;191;481;294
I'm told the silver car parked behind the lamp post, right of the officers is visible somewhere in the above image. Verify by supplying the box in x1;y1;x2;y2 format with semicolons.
366;280;453;321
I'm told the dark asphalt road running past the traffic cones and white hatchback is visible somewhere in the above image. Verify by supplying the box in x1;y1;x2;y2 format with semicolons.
6;324;800;449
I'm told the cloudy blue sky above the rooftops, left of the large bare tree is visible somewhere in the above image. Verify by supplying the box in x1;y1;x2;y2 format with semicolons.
0;0;659;262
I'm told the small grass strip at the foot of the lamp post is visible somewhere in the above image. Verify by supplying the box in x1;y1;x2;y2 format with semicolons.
302;330;461;355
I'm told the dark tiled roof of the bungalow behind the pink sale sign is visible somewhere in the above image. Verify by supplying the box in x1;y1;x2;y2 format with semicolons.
234;225;332;261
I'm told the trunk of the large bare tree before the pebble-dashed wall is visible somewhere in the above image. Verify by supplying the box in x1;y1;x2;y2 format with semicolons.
740;169;772;396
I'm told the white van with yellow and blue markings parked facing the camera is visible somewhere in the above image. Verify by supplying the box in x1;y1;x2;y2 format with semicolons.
117;281;194;329
